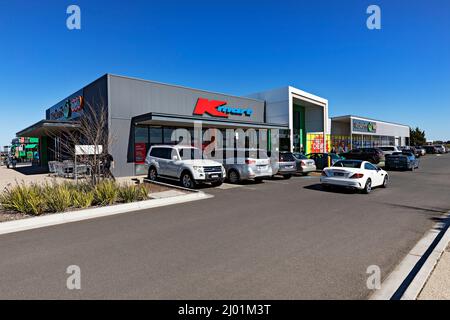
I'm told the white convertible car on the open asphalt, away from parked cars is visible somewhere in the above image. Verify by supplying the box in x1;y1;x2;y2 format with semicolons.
320;160;389;193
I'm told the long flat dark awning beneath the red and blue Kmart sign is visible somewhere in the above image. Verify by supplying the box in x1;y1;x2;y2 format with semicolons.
132;113;288;129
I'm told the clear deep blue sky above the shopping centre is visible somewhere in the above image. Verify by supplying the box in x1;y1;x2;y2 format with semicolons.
0;0;450;145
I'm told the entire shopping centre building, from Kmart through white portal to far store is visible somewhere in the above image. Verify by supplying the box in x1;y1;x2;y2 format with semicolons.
17;74;409;177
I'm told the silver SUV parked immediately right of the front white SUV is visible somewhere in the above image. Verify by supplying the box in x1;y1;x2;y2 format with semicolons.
212;148;273;183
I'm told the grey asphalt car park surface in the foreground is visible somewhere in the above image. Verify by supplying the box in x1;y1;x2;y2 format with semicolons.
0;154;450;299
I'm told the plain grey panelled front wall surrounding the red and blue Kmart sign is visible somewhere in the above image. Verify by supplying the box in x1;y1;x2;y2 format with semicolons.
108;75;264;176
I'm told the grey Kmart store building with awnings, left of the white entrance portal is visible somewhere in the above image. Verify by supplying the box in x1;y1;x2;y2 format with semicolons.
17;74;298;177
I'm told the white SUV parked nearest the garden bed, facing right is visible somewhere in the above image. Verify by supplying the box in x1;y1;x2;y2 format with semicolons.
145;145;226;189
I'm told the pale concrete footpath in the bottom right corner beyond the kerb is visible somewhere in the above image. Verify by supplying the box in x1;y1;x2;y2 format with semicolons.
417;244;450;300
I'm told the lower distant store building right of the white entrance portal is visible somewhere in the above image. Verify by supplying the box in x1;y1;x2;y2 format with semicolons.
330;115;410;152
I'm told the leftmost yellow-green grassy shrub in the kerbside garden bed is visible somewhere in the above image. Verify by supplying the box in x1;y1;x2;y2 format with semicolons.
0;183;46;215
